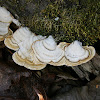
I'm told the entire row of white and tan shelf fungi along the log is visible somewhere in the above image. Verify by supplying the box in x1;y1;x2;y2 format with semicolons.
0;7;95;70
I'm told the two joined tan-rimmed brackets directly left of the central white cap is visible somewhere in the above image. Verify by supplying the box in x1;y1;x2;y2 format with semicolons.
4;27;46;70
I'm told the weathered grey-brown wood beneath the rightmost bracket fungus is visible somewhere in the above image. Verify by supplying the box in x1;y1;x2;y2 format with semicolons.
71;53;100;81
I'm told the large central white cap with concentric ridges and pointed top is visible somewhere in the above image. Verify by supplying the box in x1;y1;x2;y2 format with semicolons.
32;36;64;63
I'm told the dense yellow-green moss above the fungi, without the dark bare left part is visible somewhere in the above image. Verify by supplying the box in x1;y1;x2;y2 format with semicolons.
32;0;100;45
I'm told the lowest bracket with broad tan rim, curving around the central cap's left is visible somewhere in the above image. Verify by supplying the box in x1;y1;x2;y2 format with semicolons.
12;35;46;70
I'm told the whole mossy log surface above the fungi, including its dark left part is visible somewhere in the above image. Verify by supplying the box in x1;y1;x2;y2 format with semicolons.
0;0;100;45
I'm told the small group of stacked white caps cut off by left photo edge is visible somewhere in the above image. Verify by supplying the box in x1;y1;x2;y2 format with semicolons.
0;7;20;41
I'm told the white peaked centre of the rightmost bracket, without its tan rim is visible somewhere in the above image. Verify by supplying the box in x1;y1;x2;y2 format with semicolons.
65;40;89;62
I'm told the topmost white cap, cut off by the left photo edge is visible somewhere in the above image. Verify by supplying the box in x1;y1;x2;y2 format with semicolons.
0;7;13;23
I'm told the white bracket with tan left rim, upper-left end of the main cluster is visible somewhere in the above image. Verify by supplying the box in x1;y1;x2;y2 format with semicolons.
4;27;35;50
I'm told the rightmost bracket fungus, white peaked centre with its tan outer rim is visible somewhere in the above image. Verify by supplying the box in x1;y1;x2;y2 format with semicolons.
65;40;95;66
